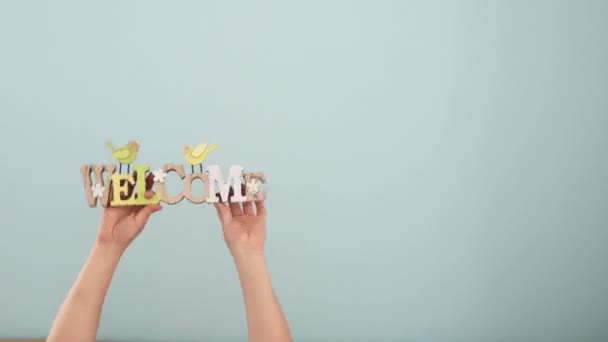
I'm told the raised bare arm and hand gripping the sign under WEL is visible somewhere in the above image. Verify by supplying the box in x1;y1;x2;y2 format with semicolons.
47;194;161;342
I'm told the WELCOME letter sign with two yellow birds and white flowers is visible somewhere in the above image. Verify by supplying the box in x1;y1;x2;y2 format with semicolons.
80;140;266;208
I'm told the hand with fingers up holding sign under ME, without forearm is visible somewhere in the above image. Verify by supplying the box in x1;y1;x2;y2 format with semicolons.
215;201;266;255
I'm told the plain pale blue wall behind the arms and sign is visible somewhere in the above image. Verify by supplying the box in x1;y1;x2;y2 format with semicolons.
0;0;608;341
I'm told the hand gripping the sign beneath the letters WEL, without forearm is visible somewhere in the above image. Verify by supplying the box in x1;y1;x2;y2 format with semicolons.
97;191;162;252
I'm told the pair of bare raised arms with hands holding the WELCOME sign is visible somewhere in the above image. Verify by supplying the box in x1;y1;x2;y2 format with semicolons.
47;191;292;342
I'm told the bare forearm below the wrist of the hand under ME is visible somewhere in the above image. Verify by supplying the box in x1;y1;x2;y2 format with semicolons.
234;248;291;342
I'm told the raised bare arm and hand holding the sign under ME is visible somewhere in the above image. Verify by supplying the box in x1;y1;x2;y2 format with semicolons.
215;202;292;342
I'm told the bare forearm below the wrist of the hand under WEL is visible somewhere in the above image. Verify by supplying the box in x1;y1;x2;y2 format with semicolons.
47;243;122;342
